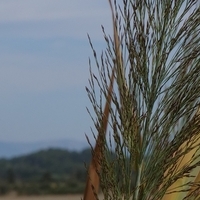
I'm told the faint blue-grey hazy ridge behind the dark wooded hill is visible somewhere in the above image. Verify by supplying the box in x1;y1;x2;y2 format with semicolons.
0;139;89;158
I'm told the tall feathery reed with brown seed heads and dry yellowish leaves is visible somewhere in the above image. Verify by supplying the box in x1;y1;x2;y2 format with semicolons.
84;0;200;200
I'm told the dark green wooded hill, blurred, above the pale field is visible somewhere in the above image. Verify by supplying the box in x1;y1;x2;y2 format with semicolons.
0;148;91;194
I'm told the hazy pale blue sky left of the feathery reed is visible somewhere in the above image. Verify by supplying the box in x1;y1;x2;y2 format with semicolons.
0;0;112;142
